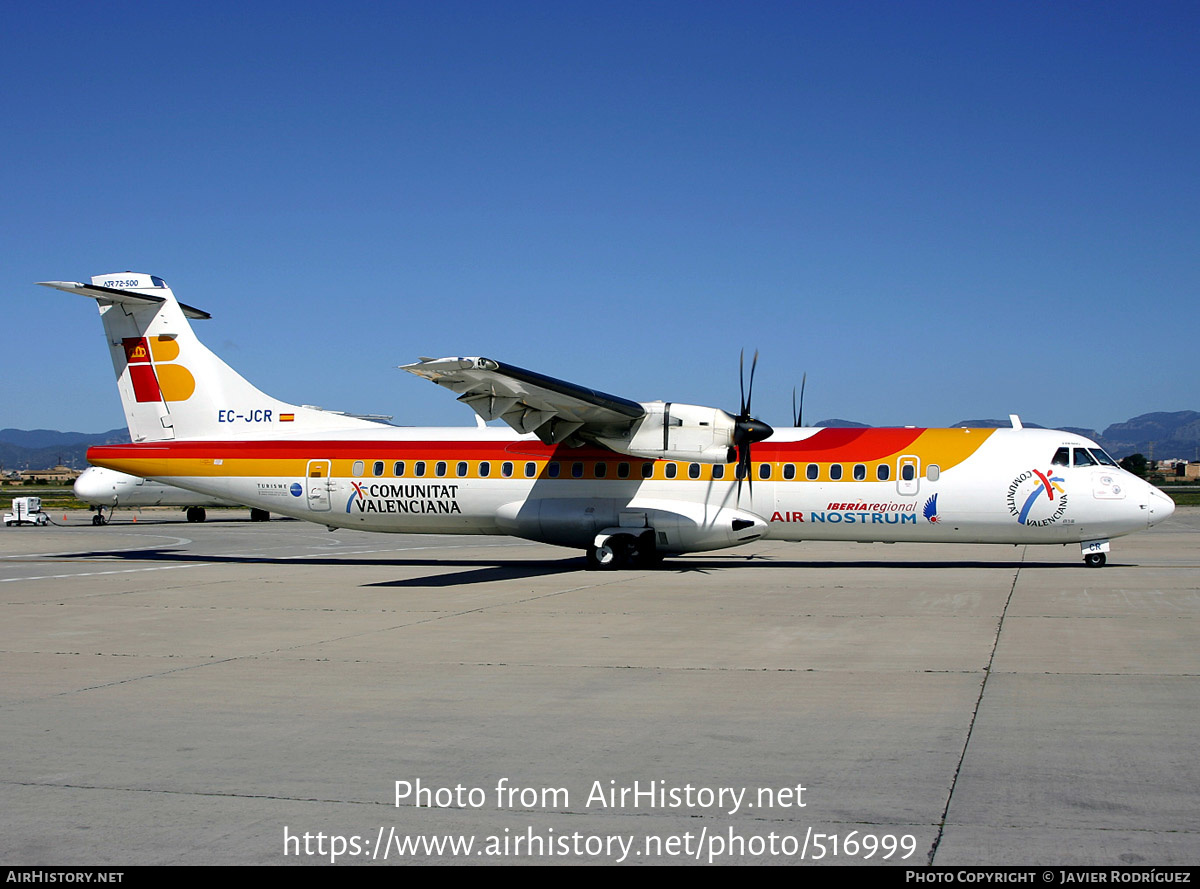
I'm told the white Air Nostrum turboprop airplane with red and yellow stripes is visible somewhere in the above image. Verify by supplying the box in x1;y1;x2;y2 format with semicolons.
40;272;1175;569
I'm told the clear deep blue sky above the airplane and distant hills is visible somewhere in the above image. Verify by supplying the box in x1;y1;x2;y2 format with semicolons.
0;1;1200;431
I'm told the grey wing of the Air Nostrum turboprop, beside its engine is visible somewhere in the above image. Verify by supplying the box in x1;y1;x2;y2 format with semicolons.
401;358;647;444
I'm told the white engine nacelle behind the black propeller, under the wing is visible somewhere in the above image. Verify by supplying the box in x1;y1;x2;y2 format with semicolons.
596;401;737;463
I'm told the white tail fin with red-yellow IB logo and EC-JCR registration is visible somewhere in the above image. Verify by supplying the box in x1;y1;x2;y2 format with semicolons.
40;272;378;442
